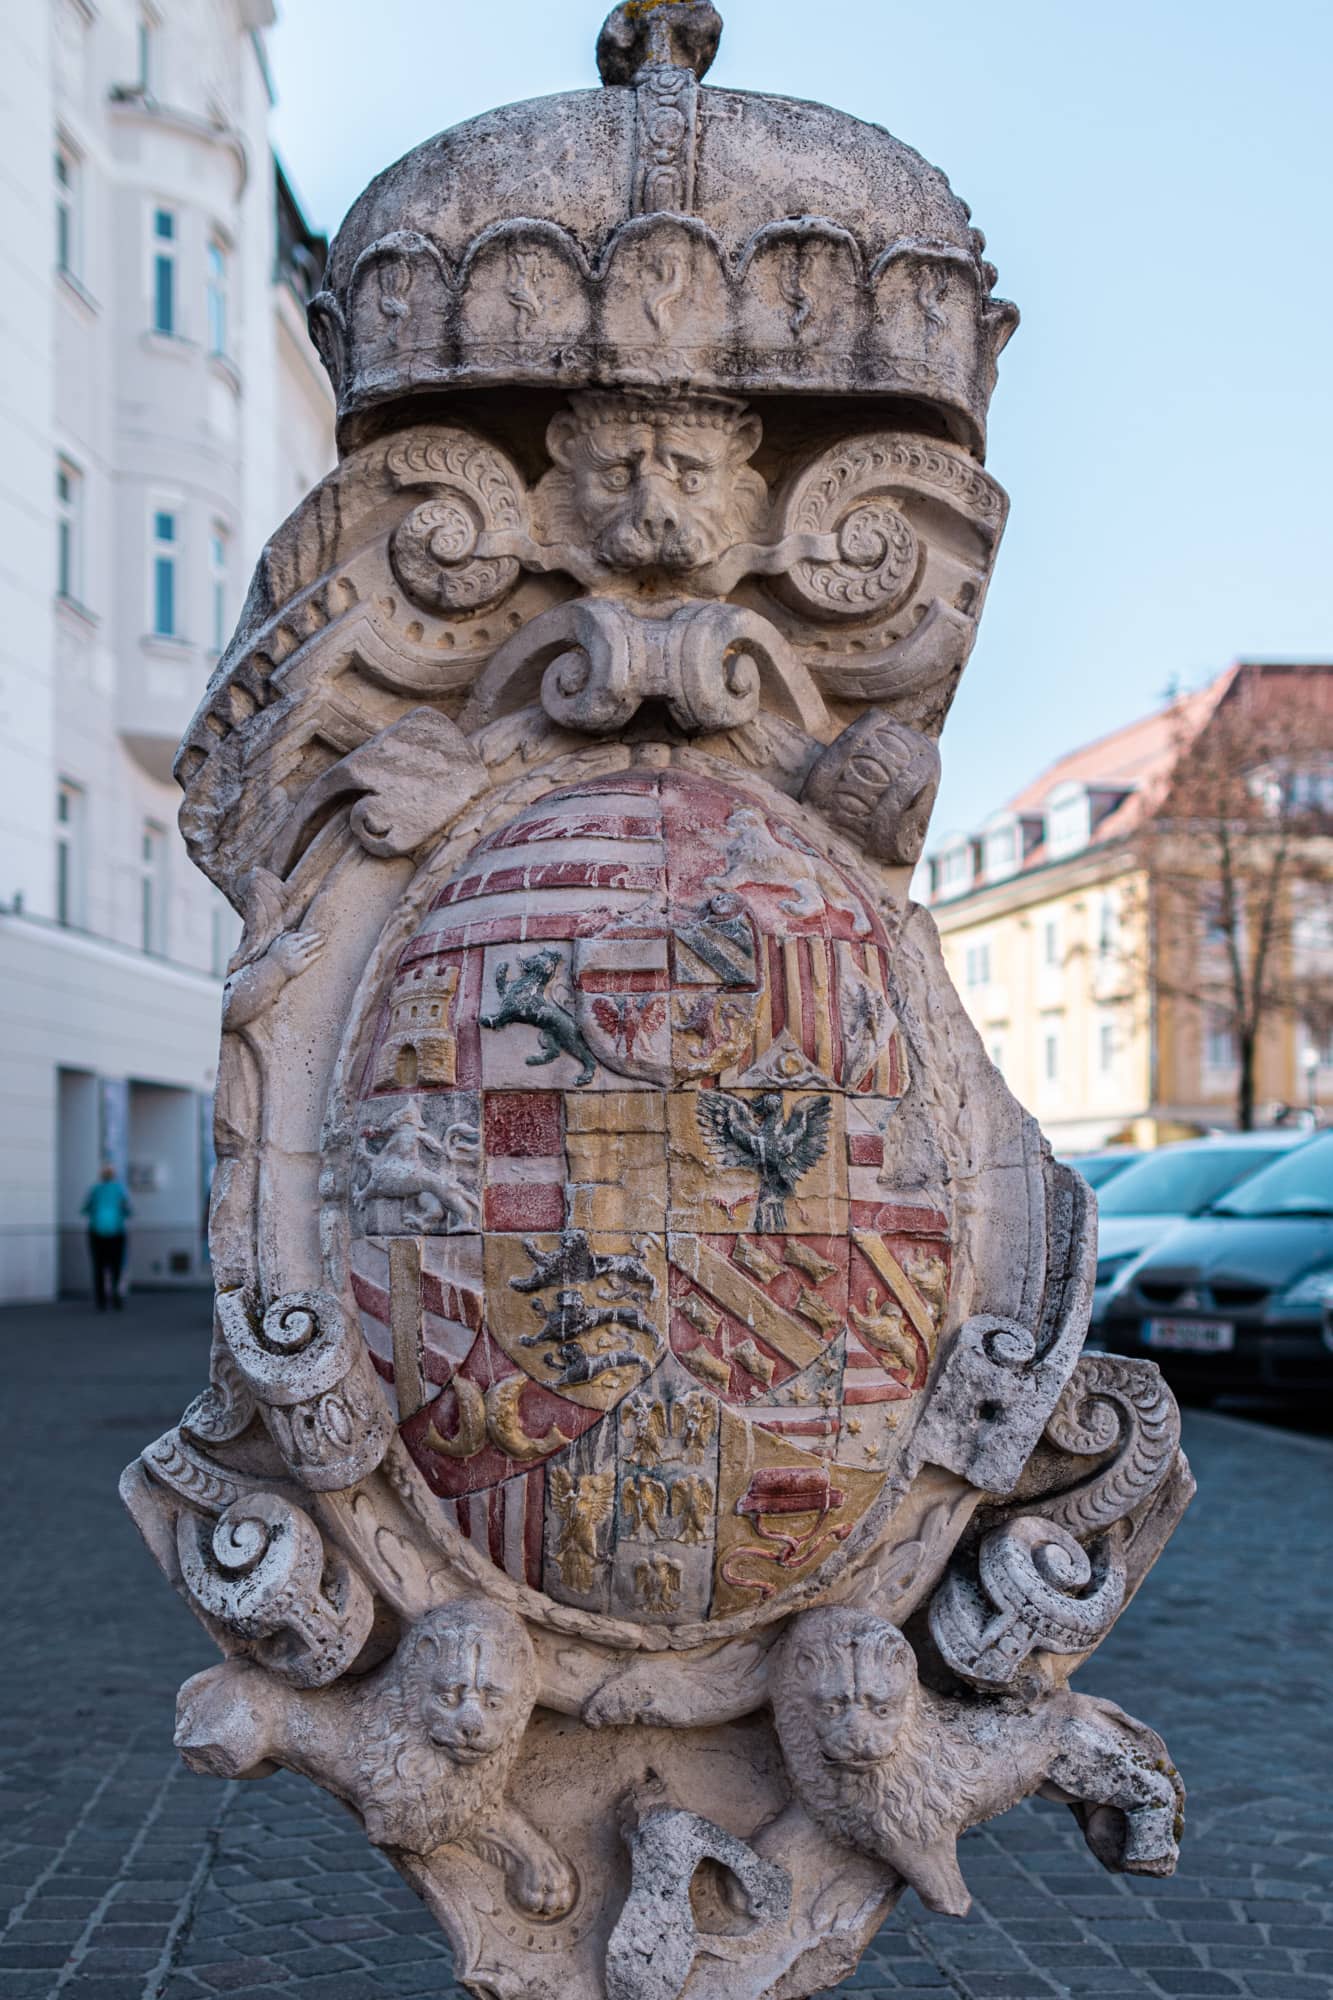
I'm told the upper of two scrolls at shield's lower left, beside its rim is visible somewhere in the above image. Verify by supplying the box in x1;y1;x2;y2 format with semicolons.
218;1292;394;1492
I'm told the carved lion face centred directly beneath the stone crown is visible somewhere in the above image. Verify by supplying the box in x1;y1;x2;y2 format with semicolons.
544;394;767;574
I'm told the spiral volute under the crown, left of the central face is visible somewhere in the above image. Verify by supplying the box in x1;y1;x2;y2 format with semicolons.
388;430;526;616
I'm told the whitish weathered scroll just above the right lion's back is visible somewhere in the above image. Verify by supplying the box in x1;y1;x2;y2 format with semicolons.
931;1514;1125;1688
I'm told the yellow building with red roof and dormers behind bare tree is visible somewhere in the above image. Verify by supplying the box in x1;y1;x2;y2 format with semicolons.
927;666;1333;1152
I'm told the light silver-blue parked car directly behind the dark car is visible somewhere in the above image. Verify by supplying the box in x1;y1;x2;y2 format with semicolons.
1093;1128;1309;1326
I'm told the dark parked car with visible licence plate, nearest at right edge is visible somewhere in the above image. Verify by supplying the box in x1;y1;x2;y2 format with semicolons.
1101;1132;1333;1396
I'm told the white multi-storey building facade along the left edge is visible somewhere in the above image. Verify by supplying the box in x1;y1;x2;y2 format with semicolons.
0;0;334;1300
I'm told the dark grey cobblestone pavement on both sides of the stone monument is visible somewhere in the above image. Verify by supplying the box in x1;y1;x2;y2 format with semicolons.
0;1294;1333;2000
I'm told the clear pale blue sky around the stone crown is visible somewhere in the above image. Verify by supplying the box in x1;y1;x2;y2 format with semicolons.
270;0;1333;846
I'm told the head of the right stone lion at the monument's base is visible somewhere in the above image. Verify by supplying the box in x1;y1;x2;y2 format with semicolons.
775;1608;917;1772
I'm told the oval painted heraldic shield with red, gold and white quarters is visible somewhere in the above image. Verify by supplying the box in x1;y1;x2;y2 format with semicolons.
342;770;951;1626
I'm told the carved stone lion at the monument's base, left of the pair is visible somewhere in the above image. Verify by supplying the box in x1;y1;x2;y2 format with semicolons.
176;1602;576;1916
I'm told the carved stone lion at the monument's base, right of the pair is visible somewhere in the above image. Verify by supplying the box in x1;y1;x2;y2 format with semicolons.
773;1608;1185;1916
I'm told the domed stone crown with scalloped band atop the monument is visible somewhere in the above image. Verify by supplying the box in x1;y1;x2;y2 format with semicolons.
310;0;1017;452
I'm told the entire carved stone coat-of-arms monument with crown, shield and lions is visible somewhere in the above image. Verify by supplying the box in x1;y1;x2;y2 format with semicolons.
122;0;1193;2000
